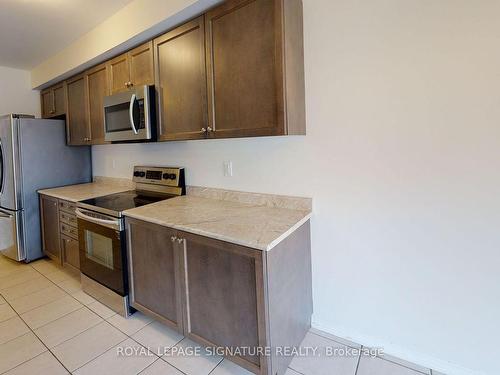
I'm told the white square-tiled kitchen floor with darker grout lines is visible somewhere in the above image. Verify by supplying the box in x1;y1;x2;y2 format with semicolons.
0;257;442;375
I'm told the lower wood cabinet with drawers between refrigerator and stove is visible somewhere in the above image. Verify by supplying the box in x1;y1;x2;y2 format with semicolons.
40;194;80;269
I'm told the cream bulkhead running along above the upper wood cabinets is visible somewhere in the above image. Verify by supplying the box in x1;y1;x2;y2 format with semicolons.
31;0;221;88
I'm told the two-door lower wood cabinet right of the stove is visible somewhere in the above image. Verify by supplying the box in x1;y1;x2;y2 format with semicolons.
126;218;312;375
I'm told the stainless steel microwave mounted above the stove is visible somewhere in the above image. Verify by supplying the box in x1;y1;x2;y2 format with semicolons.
104;86;156;142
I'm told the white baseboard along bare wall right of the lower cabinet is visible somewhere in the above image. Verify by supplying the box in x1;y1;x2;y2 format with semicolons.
312;317;488;375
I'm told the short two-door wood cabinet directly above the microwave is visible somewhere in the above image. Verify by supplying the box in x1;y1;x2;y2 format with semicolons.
107;41;154;94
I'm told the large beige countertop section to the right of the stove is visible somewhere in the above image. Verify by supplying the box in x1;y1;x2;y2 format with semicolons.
124;193;311;251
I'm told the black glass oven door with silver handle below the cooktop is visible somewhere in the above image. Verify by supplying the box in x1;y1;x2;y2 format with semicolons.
76;208;128;296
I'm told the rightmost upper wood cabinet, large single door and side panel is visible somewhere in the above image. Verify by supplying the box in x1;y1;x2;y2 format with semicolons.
205;0;305;138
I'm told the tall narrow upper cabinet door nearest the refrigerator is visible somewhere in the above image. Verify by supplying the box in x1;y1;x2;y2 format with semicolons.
66;75;90;146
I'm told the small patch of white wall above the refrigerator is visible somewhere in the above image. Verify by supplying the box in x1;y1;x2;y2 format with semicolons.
0;66;40;117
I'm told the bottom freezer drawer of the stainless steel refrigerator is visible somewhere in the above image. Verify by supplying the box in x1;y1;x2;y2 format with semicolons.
0;209;25;260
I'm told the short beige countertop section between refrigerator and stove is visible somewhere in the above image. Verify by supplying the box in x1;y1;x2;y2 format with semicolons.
38;177;134;202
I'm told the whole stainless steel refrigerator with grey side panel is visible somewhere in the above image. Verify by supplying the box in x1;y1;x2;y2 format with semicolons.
0;115;92;262
